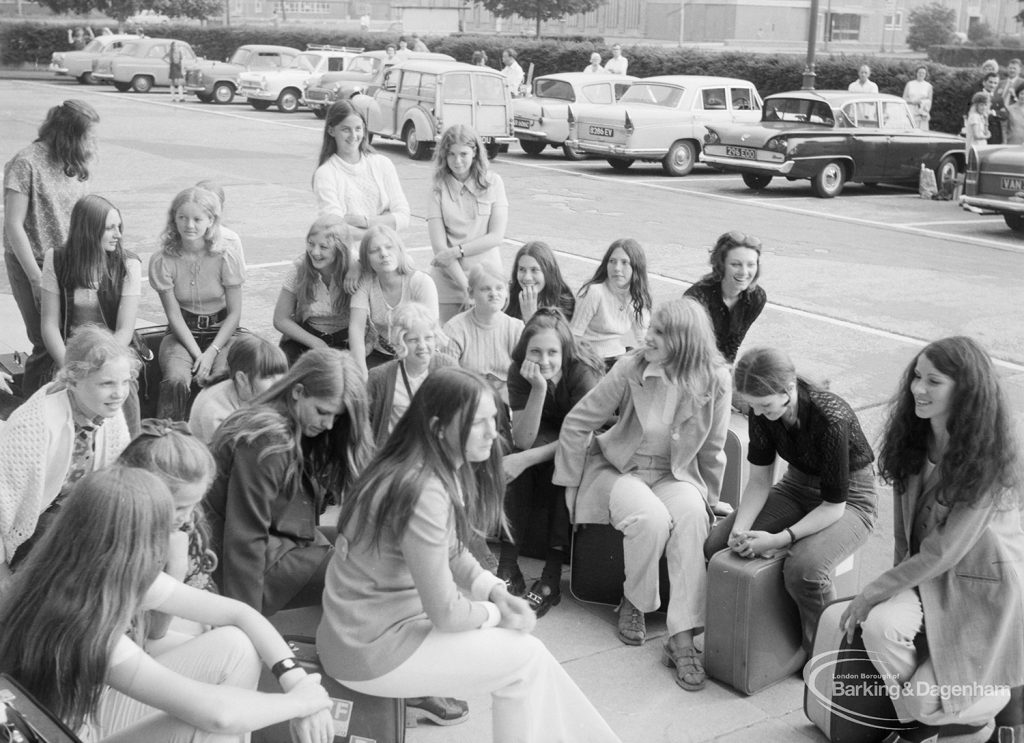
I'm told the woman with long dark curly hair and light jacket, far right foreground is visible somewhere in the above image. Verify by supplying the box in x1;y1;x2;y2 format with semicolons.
840;337;1024;741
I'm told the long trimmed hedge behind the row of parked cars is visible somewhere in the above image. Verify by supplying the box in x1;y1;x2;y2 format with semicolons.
0;21;978;132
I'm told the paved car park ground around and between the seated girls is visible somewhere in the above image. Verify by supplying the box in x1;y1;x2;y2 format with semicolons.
0;80;1024;743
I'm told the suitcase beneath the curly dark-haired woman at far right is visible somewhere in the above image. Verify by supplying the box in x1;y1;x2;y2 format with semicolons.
804;599;916;743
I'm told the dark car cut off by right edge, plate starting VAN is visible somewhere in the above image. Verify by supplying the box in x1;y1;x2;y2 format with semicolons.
963;144;1024;232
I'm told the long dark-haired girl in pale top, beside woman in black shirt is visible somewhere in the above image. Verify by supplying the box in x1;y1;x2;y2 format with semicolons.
571;237;651;368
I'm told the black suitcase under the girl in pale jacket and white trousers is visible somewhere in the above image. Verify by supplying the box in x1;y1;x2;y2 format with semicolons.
569;524;669;611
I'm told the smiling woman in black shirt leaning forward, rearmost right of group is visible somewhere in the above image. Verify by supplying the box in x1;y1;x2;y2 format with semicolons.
684;231;768;364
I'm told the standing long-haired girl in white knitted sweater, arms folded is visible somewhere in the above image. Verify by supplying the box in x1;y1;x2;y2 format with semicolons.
313;100;410;254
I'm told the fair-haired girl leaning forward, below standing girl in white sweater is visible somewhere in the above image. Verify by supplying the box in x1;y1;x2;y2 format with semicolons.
273;214;349;364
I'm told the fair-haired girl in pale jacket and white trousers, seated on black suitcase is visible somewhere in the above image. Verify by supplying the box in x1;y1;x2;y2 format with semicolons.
552;299;731;692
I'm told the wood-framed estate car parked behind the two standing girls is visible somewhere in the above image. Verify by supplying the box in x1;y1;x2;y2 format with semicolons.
362;59;515;160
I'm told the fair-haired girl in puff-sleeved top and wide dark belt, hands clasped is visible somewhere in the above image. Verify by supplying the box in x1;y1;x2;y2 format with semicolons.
150;187;246;421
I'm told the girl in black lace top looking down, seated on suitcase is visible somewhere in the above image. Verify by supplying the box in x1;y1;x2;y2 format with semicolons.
705;348;876;650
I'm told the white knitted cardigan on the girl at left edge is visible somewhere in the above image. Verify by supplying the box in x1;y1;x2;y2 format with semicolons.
0;383;131;563
